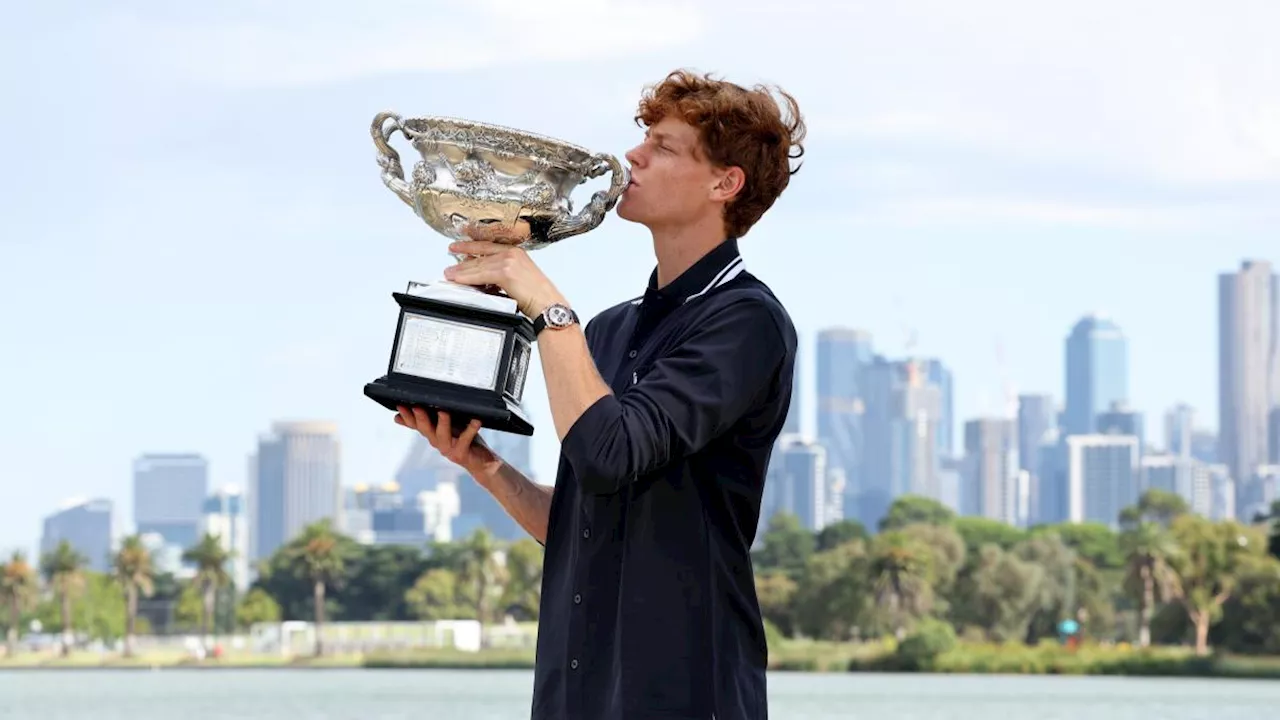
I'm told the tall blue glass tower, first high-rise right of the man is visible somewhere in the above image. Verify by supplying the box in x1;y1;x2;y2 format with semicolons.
815;328;873;518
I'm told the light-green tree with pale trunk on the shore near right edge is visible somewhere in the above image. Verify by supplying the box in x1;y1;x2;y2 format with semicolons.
1170;515;1266;655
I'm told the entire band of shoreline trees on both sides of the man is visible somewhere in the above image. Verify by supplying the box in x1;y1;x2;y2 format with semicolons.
0;491;1280;656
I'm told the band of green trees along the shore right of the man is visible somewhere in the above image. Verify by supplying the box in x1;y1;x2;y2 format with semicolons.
754;489;1280;655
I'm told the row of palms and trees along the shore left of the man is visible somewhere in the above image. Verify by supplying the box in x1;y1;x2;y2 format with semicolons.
0;520;543;657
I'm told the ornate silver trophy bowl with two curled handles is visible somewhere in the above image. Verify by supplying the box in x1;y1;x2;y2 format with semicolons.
370;113;630;250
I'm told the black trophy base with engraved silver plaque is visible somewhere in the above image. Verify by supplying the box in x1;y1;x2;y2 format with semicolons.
365;292;534;436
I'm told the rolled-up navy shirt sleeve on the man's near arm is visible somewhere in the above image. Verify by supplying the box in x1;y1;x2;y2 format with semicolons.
562;300;787;495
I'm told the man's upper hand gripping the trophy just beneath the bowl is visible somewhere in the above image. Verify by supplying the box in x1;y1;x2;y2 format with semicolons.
444;231;564;318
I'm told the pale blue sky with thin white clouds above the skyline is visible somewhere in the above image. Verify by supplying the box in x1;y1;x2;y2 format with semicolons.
0;0;1280;556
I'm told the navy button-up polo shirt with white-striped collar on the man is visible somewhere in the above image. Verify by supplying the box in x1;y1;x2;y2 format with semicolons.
532;238;796;720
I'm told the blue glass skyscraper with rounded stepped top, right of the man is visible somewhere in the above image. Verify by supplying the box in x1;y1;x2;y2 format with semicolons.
1064;314;1129;436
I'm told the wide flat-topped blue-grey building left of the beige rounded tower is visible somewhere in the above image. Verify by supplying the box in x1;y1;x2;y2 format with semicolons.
133;454;209;551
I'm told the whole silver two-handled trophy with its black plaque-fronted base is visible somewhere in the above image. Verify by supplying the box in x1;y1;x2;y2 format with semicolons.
365;113;630;436
